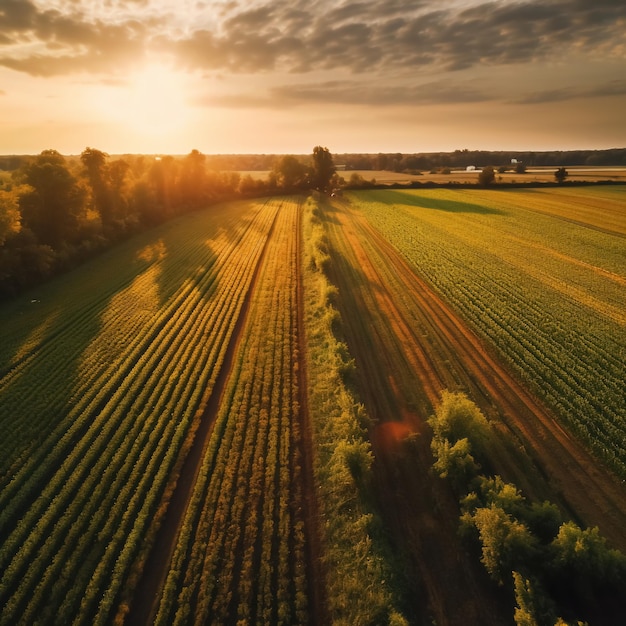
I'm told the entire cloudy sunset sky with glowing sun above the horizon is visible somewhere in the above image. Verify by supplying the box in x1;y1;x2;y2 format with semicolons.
0;0;626;154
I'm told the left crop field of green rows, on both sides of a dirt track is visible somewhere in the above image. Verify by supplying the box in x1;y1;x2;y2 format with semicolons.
0;200;314;623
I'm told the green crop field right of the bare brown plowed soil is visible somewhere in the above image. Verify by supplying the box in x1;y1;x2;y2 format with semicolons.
347;187;626;477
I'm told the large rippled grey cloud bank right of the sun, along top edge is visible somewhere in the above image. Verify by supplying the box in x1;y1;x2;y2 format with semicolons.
167;0;626;72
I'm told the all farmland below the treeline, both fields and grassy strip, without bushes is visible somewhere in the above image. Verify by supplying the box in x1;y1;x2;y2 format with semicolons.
0;187;626;624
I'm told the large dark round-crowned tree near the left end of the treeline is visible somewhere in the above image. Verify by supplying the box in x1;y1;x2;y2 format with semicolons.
19;150;85;249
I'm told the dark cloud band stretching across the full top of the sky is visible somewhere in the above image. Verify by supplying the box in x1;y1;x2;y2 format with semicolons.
0;0;626;75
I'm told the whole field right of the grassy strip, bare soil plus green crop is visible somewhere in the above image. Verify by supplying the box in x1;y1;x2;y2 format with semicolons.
324;189;626;623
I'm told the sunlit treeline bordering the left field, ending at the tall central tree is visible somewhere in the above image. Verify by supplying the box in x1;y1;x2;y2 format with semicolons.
0;146;334;297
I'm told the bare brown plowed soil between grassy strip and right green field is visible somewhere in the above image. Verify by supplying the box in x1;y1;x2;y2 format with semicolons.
326;199;626;626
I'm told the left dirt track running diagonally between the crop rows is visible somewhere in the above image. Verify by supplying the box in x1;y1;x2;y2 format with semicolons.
124;207;278;626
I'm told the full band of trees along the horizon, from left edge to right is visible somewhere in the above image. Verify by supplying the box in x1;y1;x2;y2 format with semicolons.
0;146;626;299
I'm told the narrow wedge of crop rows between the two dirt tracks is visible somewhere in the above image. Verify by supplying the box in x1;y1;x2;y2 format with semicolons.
151;199;309;624
